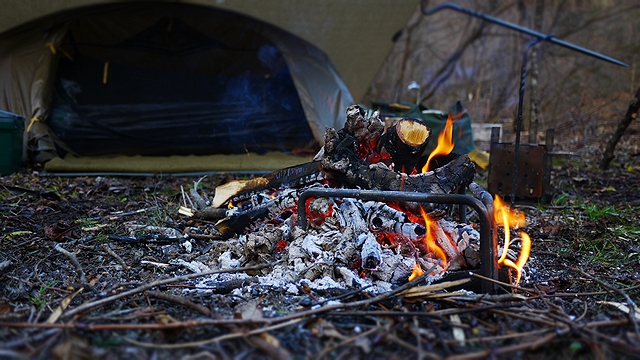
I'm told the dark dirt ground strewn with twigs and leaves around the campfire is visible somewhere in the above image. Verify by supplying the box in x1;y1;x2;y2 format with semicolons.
0;135;640;359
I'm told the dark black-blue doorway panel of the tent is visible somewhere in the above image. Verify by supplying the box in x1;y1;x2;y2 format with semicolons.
49;18;314;155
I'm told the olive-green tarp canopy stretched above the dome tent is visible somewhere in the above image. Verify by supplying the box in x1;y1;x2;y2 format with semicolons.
0;0;420;101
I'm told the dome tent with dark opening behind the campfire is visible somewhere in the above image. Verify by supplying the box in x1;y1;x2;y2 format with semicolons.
0;2;415;173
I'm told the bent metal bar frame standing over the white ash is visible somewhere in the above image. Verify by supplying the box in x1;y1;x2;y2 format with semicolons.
298;189;498;294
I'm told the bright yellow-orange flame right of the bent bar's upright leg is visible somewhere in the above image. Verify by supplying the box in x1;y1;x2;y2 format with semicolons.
493;195;531;286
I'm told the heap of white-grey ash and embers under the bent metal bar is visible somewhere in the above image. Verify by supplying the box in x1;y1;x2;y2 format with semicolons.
185;198;480;295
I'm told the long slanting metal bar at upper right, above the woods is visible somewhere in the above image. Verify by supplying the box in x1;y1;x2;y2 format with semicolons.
420;0;629;67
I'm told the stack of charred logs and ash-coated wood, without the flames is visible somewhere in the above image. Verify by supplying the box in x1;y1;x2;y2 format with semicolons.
182;105;478;279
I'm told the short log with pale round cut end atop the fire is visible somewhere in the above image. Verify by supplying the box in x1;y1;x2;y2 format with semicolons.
378;118;431;174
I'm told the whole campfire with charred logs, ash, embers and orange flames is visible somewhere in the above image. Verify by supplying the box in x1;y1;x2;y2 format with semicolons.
180;105;530;291
